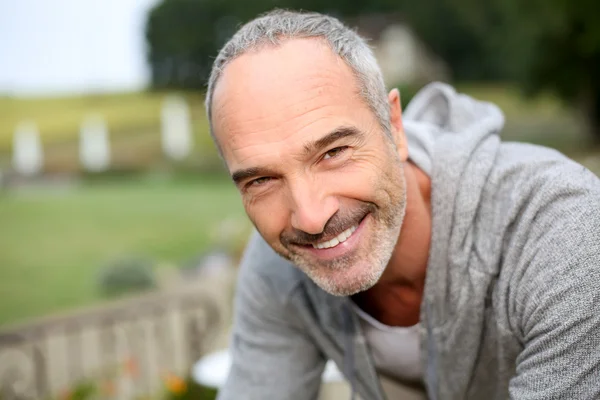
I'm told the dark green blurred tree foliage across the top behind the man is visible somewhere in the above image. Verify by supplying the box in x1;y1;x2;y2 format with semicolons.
146;0;600;138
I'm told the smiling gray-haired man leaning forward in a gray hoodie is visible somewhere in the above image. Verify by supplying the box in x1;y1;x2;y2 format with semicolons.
207;7;600;399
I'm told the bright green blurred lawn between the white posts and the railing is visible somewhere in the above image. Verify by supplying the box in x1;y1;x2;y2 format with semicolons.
0;177;248;324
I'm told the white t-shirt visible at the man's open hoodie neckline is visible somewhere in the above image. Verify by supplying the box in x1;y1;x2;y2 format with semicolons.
352;303;423;382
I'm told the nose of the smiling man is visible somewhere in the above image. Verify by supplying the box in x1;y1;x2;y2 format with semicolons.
290;180;339;235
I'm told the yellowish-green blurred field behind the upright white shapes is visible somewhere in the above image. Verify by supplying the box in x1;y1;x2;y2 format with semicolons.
0;92;220;174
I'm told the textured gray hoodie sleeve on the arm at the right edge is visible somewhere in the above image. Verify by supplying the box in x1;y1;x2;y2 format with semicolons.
509;179;600;400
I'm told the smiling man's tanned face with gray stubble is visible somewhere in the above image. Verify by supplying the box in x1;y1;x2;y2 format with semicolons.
212;39;406;296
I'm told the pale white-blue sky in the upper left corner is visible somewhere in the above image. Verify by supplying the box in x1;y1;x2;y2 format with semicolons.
0;0;159;96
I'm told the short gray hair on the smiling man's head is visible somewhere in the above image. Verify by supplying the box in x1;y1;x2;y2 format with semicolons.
206;10;391;139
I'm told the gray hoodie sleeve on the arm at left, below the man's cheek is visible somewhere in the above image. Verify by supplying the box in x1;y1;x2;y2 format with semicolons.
218;235;325;400
